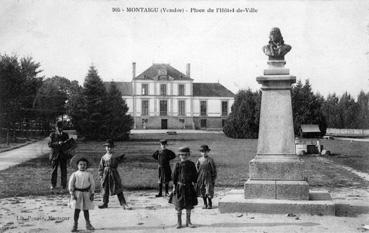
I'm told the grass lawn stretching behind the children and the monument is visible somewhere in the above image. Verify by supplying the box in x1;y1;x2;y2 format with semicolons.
0;134;369;197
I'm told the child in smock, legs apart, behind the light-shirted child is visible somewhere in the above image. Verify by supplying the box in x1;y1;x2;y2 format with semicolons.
98;139;130;209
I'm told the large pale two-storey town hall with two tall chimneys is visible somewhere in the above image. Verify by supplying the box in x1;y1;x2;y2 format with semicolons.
107;63;234;129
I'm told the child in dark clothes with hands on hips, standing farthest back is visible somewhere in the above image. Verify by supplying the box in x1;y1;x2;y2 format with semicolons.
152;139;176;197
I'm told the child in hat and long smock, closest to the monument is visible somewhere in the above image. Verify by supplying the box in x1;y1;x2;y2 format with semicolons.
196;145;217;209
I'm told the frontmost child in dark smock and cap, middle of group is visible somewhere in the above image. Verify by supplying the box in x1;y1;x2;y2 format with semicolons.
173;147;197;228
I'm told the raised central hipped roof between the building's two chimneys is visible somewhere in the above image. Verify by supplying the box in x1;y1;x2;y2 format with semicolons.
134;64;193;80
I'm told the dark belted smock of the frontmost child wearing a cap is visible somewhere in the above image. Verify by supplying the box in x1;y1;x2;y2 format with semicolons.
173;160;198;210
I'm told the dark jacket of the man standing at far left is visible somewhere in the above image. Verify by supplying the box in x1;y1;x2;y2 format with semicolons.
48;132;69;163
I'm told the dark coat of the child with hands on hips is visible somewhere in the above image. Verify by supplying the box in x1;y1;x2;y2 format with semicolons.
152;149;176;183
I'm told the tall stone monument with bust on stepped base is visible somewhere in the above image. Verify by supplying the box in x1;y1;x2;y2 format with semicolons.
219;28;335;215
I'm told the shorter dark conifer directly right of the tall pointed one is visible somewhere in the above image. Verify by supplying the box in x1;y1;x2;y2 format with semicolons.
106;82;133;140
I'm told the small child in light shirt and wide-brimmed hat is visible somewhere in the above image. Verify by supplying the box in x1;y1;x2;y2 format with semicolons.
68;155;95;232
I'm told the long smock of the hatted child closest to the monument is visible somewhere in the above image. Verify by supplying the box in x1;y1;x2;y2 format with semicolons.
196;157;217;198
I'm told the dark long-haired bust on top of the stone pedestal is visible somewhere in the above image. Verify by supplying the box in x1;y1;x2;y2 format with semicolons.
263;28;292;60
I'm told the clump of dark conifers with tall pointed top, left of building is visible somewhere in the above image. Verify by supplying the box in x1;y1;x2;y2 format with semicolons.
66;66;133;140
